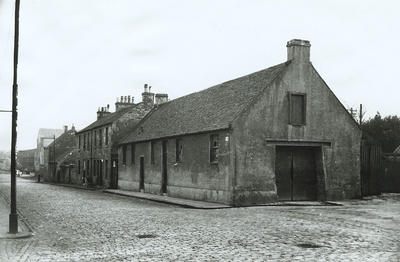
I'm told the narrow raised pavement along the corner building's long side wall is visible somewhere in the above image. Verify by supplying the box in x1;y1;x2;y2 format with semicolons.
103;189;231;209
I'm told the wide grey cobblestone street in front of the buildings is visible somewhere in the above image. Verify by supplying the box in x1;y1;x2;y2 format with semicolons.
0;175;400;261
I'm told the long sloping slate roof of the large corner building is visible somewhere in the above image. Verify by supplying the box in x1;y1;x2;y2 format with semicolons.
121;62;289;144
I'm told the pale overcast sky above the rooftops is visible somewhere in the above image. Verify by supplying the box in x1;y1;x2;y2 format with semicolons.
0;0;400;151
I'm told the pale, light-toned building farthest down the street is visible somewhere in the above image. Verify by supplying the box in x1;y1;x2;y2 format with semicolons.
35;127;65;174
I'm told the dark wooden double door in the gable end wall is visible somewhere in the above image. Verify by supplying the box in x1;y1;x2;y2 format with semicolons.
275;146;317;201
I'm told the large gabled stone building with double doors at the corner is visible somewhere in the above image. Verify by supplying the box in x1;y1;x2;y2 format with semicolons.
118;39;361;206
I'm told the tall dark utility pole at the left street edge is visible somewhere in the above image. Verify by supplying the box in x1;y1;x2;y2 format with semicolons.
9;0;20;234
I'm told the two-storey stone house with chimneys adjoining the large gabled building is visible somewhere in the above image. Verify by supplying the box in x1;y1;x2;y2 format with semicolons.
76;84;164;188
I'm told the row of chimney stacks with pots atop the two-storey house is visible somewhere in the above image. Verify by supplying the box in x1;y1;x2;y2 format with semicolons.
97;84;168;119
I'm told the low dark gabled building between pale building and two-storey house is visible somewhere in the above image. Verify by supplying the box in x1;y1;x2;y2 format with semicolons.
43;126;78;183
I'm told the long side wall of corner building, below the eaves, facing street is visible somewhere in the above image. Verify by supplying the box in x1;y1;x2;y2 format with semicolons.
118;131;231;203
